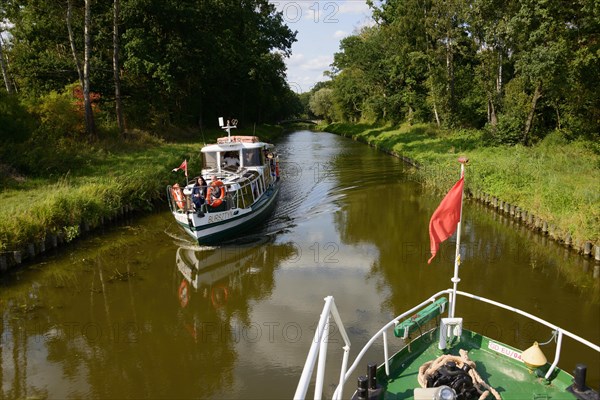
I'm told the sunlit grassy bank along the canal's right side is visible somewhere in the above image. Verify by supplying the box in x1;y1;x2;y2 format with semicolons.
323;124;600;246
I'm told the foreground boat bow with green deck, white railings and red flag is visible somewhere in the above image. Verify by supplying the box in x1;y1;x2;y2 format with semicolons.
294;158;600;400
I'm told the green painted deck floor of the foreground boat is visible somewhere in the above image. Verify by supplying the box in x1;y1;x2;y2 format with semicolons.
377;328;575;400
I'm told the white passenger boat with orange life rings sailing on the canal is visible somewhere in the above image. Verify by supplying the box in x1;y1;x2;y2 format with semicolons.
167;118;280;244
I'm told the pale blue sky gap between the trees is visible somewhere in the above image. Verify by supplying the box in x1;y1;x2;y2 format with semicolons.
270;0;372;93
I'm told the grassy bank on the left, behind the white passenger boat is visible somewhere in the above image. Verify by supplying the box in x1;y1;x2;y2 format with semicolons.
0;126;282;252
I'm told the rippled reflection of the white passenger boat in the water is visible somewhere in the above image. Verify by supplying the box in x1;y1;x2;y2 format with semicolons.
175;237;298;328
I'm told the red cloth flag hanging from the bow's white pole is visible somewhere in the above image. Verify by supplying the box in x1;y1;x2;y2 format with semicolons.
427;177;465;264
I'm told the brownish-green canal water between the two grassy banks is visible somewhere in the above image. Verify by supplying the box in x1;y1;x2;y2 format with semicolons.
0;131;600;399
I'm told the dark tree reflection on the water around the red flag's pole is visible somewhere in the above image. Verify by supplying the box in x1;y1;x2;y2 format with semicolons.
336;165;600;313
